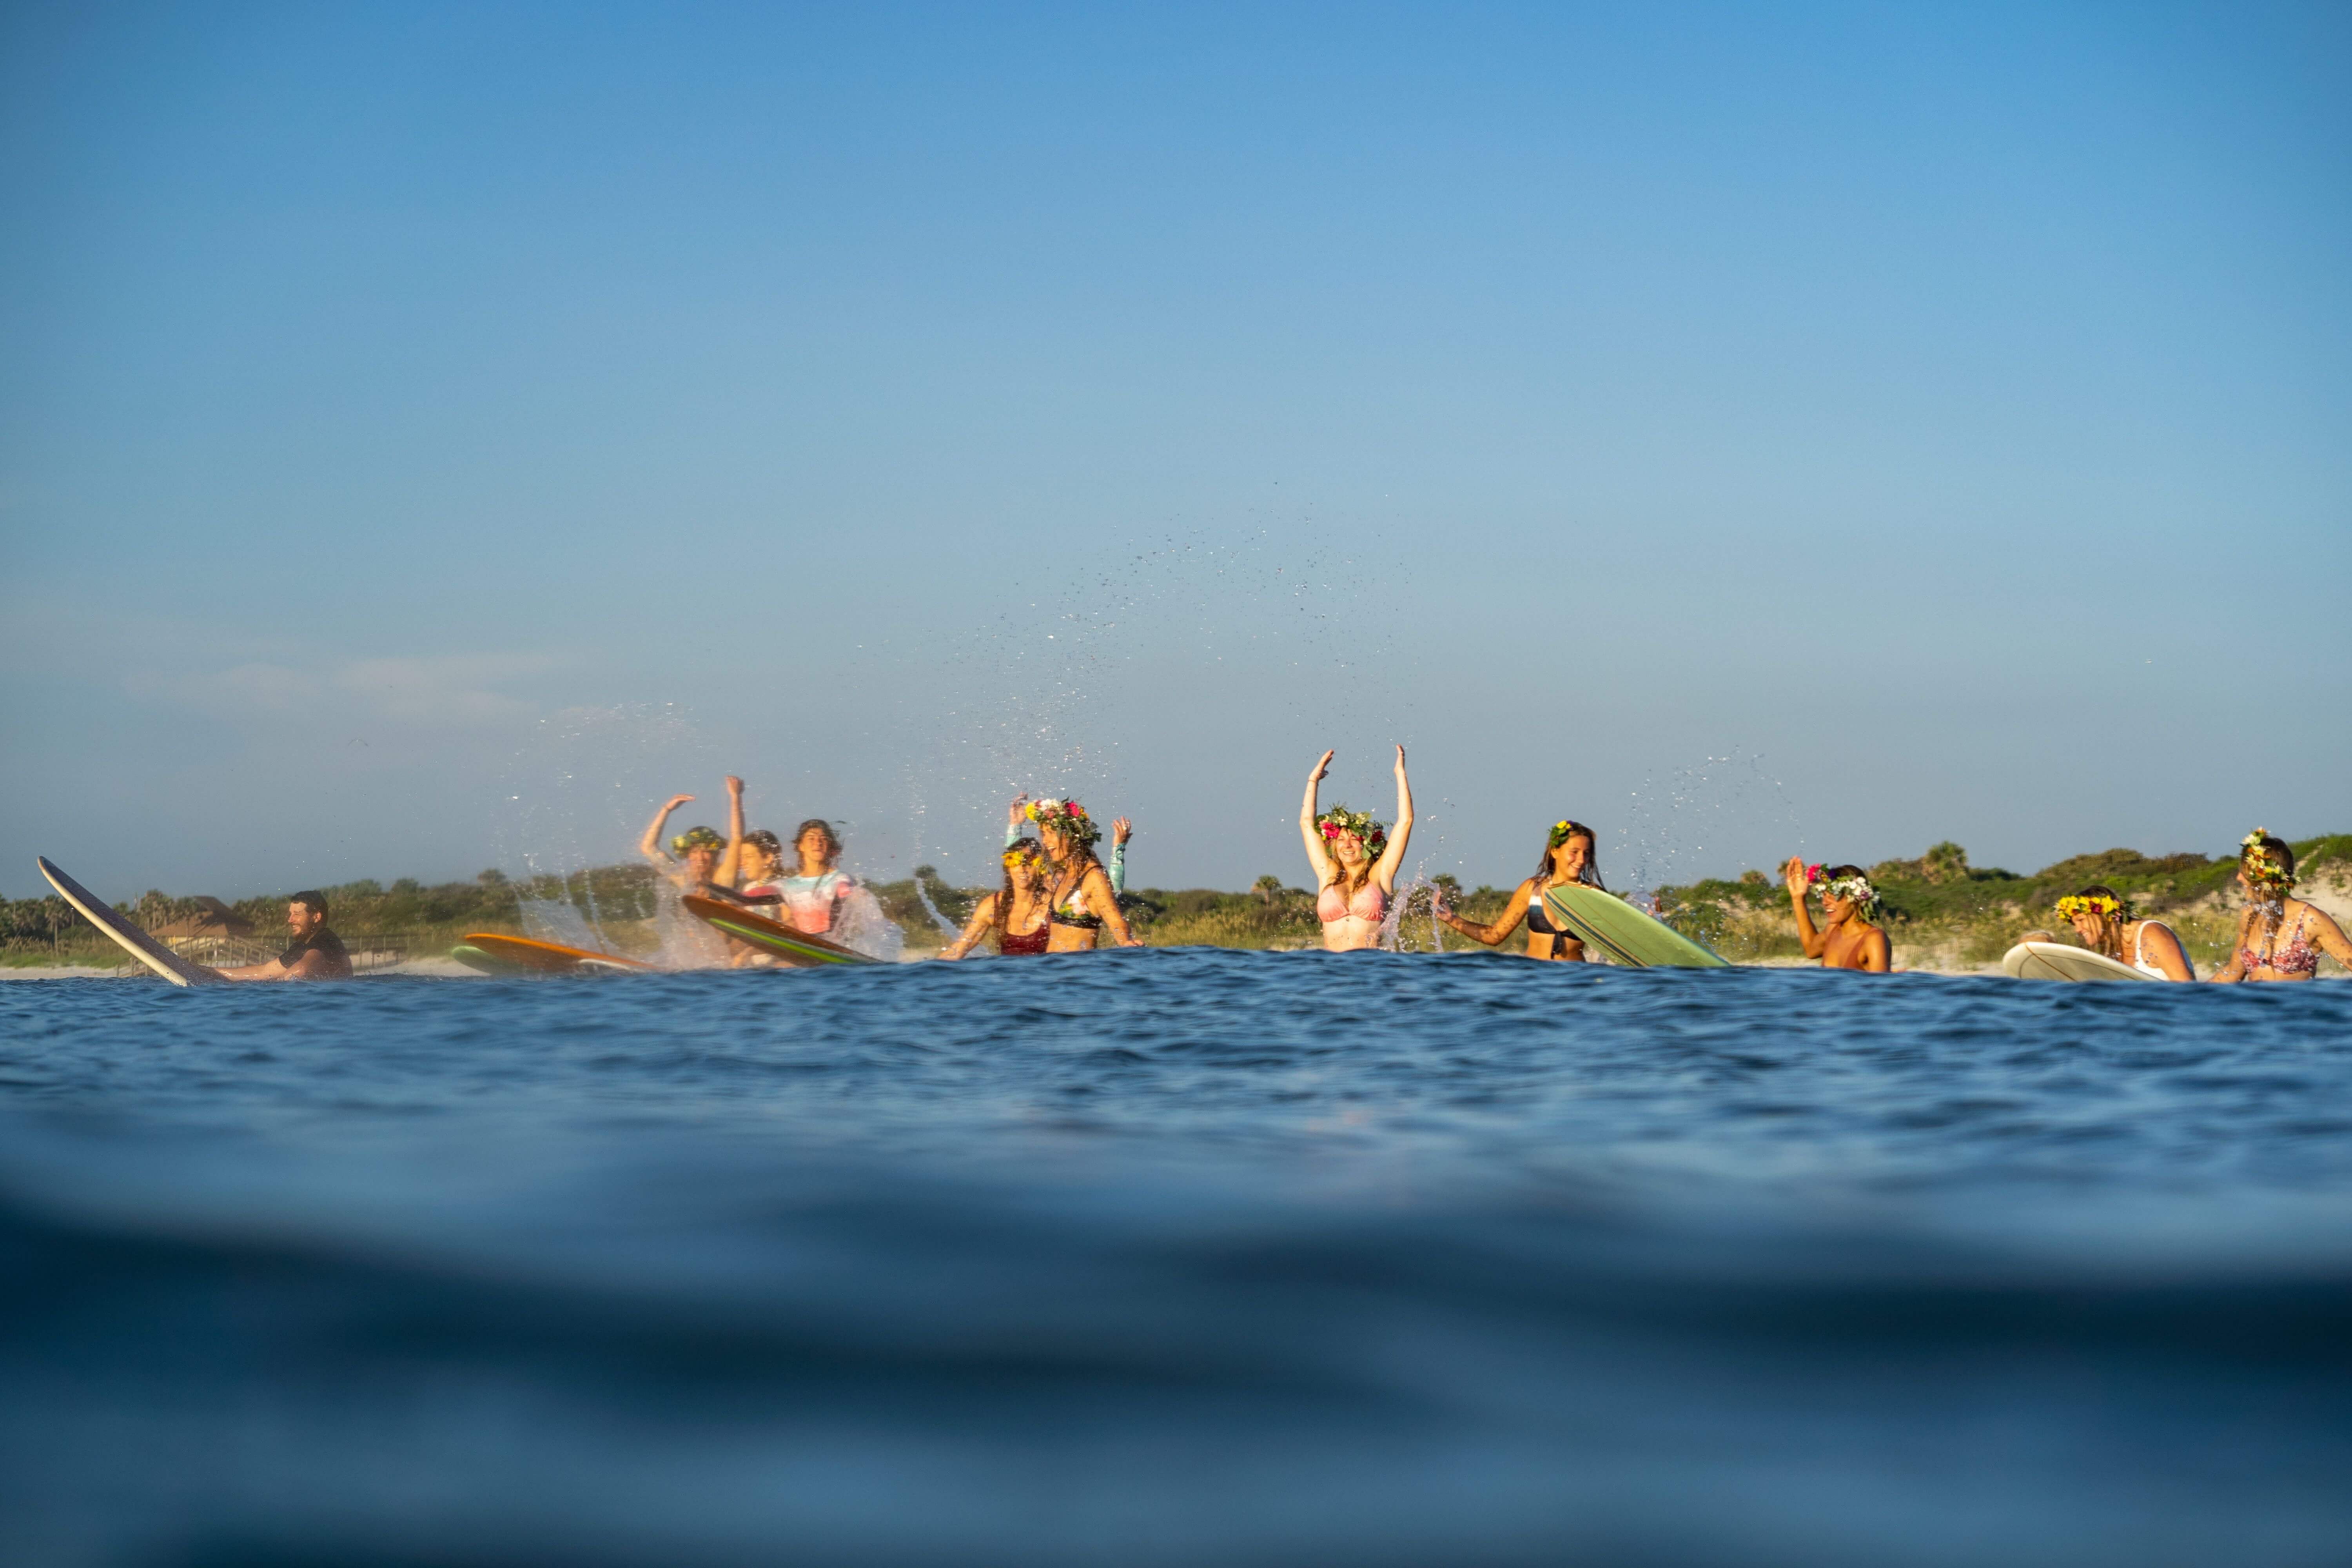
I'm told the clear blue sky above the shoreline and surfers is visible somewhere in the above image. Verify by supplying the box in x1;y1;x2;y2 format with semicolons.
0;5;2352;896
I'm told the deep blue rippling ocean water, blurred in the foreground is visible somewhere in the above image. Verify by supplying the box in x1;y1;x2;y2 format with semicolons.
0;950;2352;1568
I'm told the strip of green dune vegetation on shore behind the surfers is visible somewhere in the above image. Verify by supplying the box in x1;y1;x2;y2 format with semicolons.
0;835;2352;973
